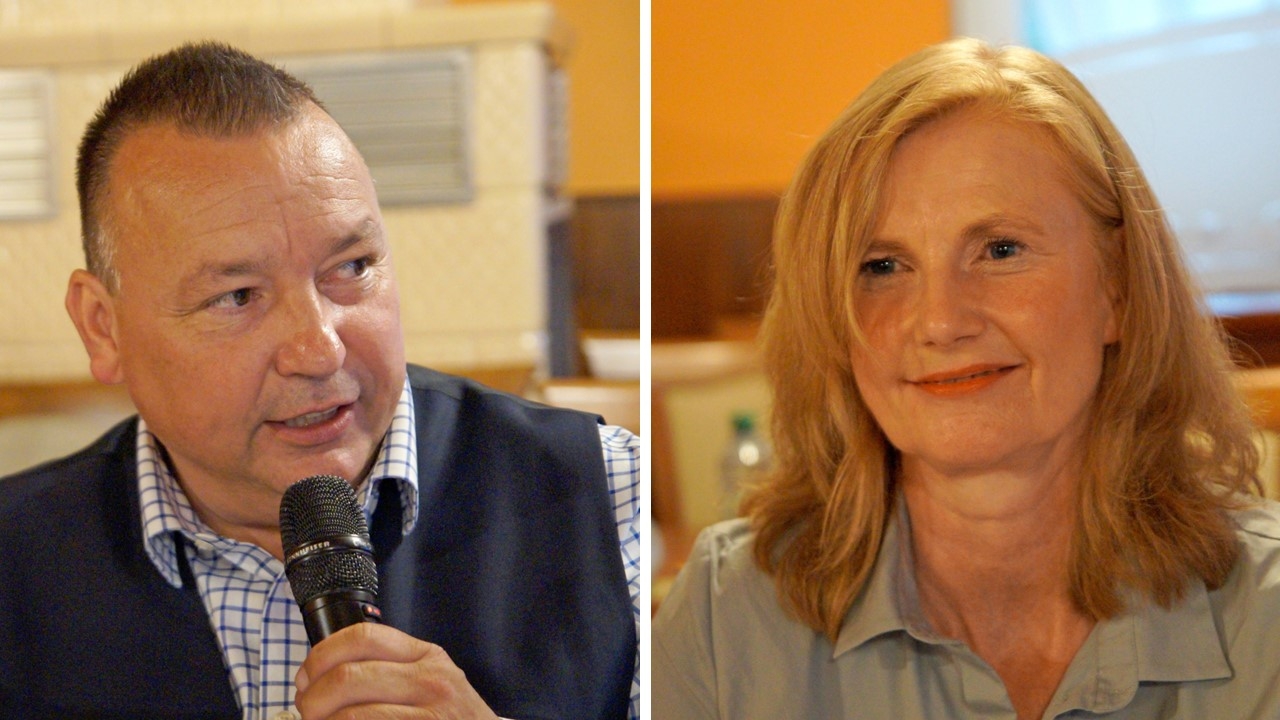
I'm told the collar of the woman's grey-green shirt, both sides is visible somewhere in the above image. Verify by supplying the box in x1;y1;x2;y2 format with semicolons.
832;502;1231;686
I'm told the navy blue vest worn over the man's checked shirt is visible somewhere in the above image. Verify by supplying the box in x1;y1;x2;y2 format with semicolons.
0;366;636;720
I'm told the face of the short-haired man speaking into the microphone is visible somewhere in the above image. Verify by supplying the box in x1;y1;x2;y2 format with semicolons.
95;106;404;529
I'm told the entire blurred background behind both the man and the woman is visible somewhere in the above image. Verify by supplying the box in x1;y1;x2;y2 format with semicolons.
10;0;1280;609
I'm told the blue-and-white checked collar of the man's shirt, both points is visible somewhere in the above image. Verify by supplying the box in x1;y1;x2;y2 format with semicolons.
137;378;417;587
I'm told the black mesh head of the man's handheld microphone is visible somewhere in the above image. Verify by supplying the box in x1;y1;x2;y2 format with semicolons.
280;475;378;605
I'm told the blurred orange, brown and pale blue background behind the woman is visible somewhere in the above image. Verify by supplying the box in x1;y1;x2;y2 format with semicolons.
650;0;1280;598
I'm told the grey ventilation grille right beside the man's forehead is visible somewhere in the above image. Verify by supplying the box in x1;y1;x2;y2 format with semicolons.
287;49;472;205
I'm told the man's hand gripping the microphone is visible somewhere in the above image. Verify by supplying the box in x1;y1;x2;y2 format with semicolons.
294;623;495;720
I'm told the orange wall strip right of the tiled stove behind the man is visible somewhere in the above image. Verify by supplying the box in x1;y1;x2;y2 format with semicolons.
453;0;640;197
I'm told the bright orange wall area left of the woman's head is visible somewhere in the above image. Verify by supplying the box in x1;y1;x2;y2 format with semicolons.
650;0;951;199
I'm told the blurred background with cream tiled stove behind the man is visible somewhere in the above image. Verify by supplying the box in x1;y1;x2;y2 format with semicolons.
0;0;640;474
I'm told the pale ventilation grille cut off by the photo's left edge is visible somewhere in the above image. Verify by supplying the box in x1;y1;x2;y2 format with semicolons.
0;72;54;219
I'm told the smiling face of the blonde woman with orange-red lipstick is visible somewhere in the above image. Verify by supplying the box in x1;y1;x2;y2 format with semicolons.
851;110;1116;475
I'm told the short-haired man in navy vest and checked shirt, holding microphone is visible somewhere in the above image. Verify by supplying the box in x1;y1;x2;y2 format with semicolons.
0;44;639;720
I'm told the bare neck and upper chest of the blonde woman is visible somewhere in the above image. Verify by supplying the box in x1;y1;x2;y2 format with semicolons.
902;462;1093;717
